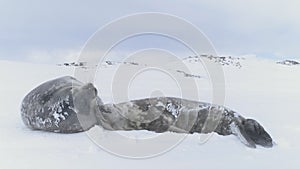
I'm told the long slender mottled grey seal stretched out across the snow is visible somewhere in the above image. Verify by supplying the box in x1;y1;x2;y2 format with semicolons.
96;97;273;148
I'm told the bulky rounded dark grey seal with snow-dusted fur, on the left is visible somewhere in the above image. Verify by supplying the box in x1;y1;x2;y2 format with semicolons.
21;76;103;133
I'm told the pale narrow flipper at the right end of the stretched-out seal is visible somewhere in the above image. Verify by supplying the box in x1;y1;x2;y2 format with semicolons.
230;123;256;148
